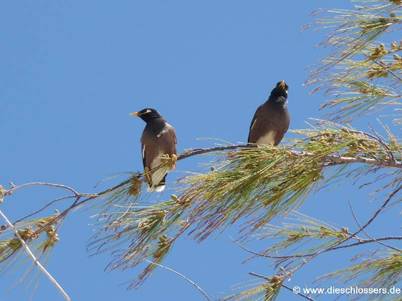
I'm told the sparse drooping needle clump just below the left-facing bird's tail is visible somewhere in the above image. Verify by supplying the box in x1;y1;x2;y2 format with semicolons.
89;180;186;287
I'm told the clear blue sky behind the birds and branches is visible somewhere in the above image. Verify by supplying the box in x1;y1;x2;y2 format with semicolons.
0;0;398;301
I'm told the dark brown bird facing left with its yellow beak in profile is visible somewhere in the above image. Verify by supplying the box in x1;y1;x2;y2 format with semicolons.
131;108;177;192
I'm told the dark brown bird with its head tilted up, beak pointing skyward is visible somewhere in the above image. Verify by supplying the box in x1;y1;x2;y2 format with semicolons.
248;80;290;145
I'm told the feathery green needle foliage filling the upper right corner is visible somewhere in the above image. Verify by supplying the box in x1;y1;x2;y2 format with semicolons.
308;1;402;120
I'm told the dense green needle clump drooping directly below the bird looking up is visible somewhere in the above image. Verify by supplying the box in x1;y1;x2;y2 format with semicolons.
182;146;323;240
